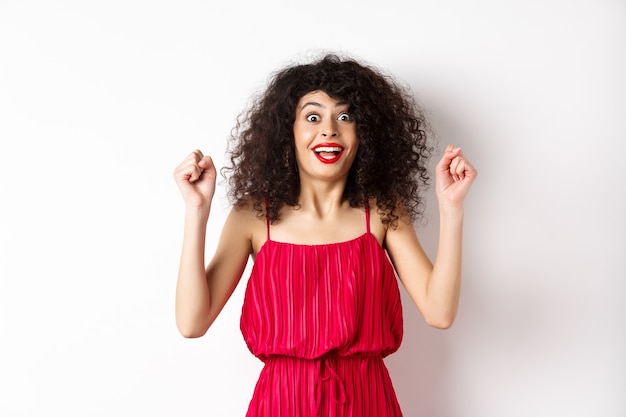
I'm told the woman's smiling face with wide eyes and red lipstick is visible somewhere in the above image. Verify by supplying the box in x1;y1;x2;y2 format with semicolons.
293;91;359;180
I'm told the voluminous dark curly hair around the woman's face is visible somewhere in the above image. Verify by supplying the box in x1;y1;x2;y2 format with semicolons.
222;54;433;227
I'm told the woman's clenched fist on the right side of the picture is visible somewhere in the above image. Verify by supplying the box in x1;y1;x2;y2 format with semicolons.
435;145;478;207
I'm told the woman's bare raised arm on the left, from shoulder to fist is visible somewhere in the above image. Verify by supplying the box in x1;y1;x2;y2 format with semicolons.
174;151;250;337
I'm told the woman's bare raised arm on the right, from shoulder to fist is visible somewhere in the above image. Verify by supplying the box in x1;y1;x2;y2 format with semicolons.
385;145;477;329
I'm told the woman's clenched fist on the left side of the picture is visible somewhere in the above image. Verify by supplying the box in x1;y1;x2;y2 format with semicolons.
174;150;217;210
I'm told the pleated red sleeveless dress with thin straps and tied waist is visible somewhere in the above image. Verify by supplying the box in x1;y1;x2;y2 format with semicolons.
241;209;402;417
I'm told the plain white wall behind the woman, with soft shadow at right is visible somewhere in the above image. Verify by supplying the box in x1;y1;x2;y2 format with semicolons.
0;0;626;417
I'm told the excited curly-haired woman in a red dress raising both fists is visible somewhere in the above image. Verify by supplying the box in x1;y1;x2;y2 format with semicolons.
174;55;477;417
